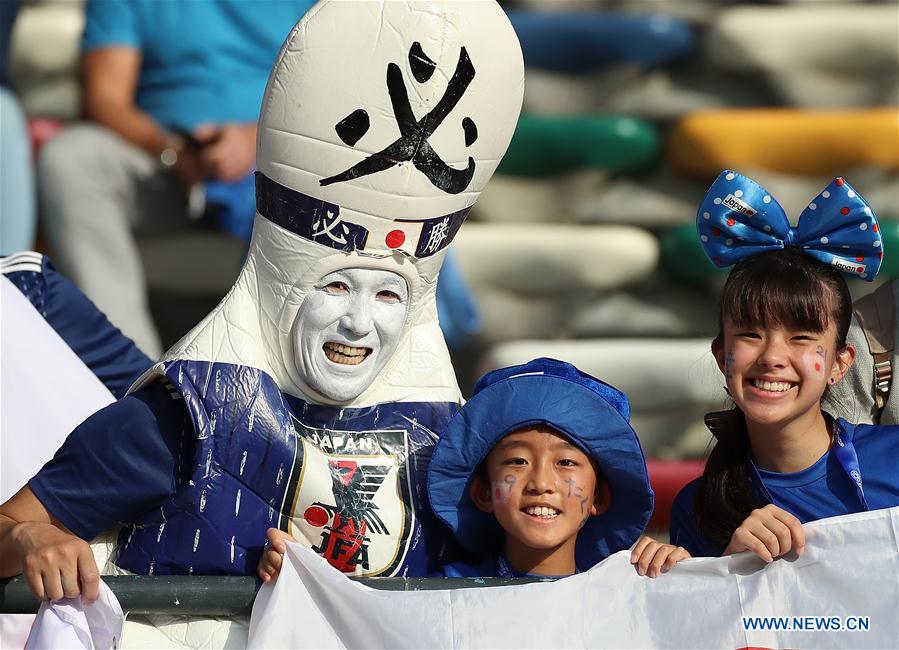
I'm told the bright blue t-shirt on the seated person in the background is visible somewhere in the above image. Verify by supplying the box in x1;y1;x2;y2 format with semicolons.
81;0;312;132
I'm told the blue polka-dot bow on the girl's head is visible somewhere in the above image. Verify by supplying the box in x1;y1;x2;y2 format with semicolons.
696;170;883;281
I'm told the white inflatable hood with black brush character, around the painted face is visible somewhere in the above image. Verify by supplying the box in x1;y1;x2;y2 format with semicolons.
137;0;524;407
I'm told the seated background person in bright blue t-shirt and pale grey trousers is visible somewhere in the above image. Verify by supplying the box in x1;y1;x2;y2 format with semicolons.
38;0;312;357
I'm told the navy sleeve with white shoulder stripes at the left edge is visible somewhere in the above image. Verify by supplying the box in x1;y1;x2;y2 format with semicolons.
0;252;153;398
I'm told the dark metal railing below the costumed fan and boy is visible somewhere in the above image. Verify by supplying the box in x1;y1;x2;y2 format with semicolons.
0;576;552;616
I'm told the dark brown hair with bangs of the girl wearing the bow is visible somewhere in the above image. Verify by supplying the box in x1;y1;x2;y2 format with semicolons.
694;248;852;546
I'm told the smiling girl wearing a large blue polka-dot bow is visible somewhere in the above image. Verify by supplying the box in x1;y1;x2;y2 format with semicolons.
670;171;899;562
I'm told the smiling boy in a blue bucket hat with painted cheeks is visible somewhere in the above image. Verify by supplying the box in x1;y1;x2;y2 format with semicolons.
428;358;679;577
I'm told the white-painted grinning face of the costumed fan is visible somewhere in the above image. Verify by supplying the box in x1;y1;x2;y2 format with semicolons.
291;269;409;402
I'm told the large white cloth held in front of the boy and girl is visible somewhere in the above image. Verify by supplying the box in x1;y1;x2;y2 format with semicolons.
249;508;899;648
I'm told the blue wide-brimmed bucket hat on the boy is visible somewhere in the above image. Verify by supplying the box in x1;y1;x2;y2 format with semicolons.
428;358;653;569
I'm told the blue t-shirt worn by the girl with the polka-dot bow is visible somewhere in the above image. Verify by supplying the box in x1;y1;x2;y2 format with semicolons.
669;419;899;557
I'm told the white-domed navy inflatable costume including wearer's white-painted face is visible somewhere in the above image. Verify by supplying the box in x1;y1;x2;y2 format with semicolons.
116;0;524;575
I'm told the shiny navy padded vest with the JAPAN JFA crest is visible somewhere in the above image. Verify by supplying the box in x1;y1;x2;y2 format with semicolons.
115;361;458;576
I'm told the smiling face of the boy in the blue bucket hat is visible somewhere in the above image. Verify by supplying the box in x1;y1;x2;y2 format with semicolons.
471;426;600;552
